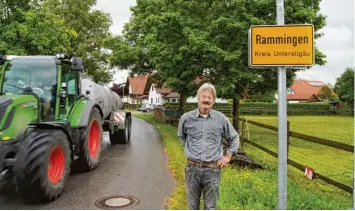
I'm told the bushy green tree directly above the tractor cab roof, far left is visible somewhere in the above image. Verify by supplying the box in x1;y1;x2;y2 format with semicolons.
0;3;76;55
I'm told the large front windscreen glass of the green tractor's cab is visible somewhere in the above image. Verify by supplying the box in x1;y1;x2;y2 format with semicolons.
1;57;57;119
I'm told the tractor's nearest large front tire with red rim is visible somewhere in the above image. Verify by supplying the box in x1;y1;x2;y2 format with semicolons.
13;130;71;203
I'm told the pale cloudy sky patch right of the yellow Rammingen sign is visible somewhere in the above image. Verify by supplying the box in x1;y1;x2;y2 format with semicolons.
298;0;355;85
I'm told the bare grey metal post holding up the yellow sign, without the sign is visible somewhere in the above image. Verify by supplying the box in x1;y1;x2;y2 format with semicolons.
276;0;287;210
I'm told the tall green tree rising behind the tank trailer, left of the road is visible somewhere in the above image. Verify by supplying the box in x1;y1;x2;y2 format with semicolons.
43;0;112;83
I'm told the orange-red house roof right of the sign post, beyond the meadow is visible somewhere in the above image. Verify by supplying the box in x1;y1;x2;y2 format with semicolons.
287;80;326;103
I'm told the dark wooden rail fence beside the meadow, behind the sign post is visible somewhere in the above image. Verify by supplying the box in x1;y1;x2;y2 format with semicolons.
239;118;354;193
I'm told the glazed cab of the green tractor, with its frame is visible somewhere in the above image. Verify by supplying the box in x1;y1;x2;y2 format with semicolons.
0;54;83;122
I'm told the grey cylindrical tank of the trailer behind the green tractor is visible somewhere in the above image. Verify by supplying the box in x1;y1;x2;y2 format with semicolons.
80;75;123;118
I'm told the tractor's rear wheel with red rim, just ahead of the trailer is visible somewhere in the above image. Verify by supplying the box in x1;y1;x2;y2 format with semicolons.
72;108;102;172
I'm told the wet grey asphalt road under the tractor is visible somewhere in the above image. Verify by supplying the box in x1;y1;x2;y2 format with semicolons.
0;118;175;210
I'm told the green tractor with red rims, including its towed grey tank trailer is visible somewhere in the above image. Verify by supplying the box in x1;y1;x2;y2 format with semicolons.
0;54;132;202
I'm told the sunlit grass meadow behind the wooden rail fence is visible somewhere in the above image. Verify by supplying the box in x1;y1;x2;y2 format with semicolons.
239;116;354;190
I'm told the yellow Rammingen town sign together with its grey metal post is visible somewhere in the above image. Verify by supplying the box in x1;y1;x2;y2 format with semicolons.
248;0;316;210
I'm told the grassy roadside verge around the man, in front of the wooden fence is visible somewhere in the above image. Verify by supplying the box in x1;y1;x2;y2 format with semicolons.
134;114;351;210
